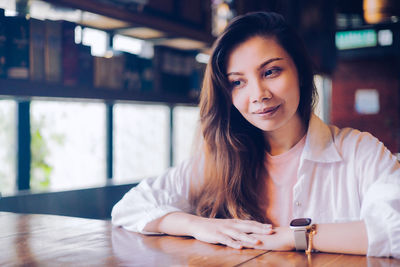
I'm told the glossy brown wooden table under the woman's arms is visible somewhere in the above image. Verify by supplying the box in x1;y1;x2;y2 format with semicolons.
0;212;400;267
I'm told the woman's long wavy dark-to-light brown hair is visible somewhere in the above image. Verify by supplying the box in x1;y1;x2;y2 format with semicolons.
190;12;316;221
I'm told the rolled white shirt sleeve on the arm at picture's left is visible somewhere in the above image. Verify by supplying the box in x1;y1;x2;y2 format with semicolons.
111;157;201;234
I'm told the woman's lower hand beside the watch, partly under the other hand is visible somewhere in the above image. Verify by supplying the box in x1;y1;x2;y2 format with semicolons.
251;227;294;251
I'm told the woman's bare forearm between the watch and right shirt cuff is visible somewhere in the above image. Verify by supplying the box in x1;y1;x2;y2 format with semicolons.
313;221;368;255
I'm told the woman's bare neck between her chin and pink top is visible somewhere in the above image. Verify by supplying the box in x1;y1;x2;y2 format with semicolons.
264;115;306;156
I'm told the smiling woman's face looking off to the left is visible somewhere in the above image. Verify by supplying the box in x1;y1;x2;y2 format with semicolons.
227;36;301;135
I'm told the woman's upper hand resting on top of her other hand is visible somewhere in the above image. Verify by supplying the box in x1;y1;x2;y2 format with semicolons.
189;216;273;249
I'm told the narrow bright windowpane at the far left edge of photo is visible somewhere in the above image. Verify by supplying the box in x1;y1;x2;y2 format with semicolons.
0;100;16;195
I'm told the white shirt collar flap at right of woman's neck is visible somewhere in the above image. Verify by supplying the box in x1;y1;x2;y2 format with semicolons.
302;114;343;163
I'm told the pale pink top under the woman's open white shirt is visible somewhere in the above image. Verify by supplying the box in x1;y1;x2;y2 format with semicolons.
262;135;306;226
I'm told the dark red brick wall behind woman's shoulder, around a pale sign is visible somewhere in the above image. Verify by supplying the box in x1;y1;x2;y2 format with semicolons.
331;58;400;153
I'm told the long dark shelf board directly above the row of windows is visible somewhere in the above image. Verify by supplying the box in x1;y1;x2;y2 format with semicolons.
0;79;198;105
